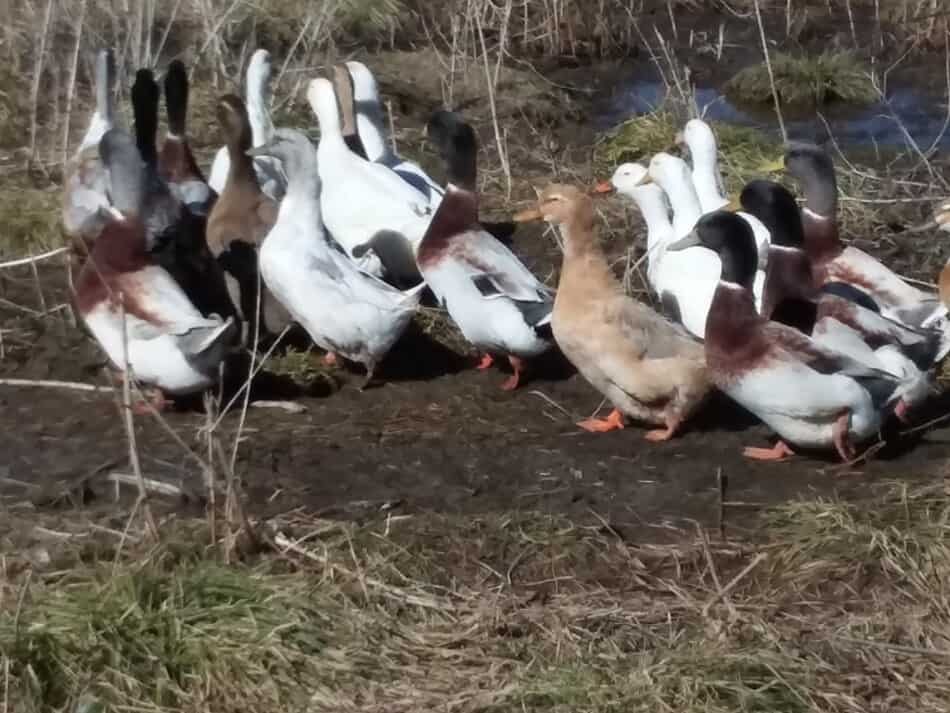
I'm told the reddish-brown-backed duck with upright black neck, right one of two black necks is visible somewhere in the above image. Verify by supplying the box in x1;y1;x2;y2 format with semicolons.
158;59;217;217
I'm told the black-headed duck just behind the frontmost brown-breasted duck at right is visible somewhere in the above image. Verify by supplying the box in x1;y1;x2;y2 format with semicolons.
740;180;936;421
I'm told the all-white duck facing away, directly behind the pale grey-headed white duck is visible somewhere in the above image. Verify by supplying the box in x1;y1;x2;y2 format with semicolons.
307;77;433;287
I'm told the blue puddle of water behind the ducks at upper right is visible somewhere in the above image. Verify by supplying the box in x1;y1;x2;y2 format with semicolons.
598;79;950;150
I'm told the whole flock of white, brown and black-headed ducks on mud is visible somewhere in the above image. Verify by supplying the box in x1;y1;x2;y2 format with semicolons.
57;50;950;460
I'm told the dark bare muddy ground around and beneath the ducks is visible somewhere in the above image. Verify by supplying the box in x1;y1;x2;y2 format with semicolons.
0;5;950;540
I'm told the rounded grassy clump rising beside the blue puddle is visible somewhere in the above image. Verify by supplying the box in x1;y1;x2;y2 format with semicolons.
725;52;877;108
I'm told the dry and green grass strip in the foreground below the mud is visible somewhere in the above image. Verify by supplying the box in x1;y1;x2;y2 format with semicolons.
0;486;950;713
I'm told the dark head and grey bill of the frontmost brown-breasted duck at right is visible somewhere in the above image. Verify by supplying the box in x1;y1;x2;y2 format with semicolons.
667;210;759;289
